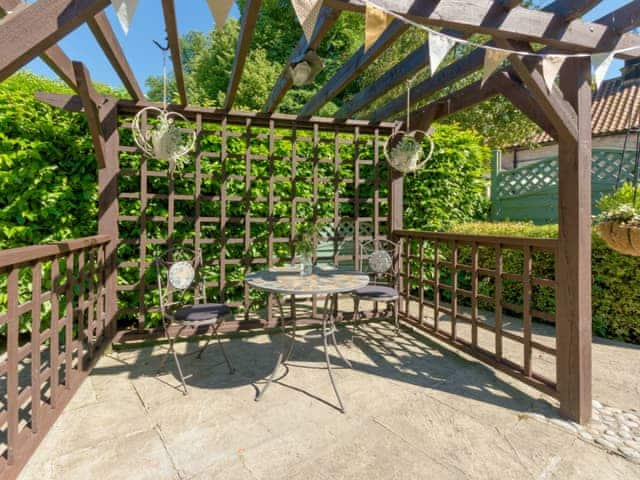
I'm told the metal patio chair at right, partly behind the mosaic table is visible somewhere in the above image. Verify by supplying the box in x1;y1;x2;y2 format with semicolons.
353;239;400;333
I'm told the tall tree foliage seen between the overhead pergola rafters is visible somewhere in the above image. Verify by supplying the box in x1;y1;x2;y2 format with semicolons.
142;0;537;148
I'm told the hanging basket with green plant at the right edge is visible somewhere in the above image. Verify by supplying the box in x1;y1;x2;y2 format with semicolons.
594;183;640;257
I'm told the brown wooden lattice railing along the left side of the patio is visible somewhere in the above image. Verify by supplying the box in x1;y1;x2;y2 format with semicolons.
0;235;115;478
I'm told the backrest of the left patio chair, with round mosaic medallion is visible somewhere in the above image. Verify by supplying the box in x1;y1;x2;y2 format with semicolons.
153;246;207;312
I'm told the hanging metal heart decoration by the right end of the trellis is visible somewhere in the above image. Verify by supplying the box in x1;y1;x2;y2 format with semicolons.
384;81;435;174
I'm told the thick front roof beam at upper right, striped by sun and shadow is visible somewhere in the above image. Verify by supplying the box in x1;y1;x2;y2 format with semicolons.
325;0;640;56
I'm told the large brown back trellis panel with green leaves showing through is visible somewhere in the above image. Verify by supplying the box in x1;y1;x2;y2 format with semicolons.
118;117;388;328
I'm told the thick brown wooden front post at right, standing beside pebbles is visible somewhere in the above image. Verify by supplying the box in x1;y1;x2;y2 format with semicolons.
556;58;591;423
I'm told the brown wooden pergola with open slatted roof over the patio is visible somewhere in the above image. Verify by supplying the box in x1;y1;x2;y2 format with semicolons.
0;0;640;476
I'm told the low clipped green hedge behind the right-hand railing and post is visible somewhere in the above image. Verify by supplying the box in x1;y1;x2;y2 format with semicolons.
452;222;640;344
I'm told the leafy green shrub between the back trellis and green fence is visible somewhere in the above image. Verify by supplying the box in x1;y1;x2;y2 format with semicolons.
404;125;491;231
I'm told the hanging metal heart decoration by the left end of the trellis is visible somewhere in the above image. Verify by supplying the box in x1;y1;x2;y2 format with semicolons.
131;40;196;169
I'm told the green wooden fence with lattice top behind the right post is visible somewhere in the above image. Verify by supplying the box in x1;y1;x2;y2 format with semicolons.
491;148;635;224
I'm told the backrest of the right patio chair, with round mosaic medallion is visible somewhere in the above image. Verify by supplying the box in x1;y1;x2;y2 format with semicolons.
360;238;400;287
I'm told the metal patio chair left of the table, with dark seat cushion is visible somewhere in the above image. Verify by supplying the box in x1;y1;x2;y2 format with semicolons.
154;247;235;395
